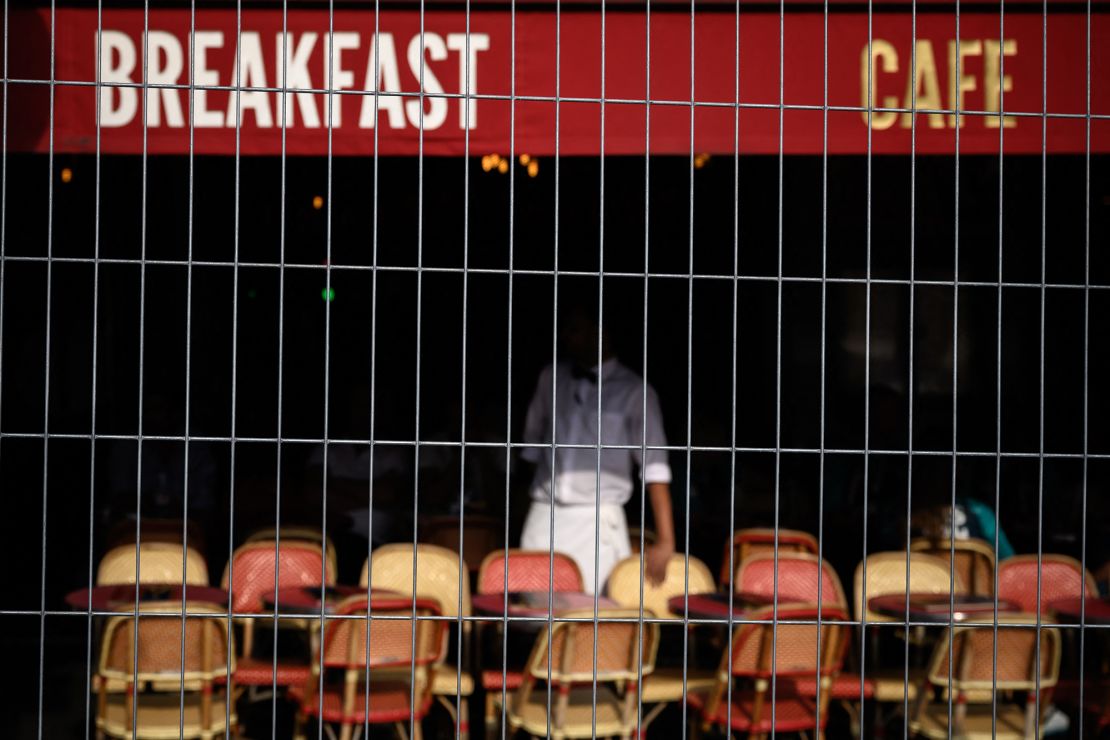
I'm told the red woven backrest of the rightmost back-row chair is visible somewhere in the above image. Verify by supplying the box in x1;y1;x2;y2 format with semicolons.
998;554;1098;612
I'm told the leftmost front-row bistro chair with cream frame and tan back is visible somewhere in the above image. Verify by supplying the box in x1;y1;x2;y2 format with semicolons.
95;601;236;740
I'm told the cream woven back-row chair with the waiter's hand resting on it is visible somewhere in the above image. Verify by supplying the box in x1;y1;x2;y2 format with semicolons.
607;554;716;732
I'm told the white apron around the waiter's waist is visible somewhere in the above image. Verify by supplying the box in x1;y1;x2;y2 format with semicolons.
521;501;632;594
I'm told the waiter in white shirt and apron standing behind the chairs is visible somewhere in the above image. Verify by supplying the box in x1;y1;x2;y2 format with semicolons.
521;306;675;592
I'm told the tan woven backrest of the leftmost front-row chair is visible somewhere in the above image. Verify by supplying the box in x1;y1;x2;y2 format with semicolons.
99;601;235;686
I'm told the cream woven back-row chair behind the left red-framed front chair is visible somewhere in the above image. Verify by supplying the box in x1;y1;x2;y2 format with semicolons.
359;543;474;740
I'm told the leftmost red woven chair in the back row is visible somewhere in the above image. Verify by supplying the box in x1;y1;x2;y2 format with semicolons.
221;540;335;688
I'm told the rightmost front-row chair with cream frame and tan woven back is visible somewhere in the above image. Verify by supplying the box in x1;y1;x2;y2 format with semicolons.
909;615;1060;740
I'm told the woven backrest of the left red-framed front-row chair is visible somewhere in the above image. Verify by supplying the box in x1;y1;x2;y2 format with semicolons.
313;595;447;671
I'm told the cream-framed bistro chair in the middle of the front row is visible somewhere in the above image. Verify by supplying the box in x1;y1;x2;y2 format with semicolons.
495;609;659;740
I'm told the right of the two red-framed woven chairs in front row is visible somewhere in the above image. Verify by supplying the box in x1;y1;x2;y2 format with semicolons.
687;605;848;738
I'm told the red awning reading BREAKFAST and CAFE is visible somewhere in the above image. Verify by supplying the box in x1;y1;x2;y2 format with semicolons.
8;0;1110;155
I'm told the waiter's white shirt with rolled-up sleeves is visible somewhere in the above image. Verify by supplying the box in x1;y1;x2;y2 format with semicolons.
521;359;670;506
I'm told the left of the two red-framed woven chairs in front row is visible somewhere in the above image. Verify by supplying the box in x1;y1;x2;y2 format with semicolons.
290;596;448;740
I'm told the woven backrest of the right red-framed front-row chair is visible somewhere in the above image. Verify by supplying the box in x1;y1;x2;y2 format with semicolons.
720;604;848;678
